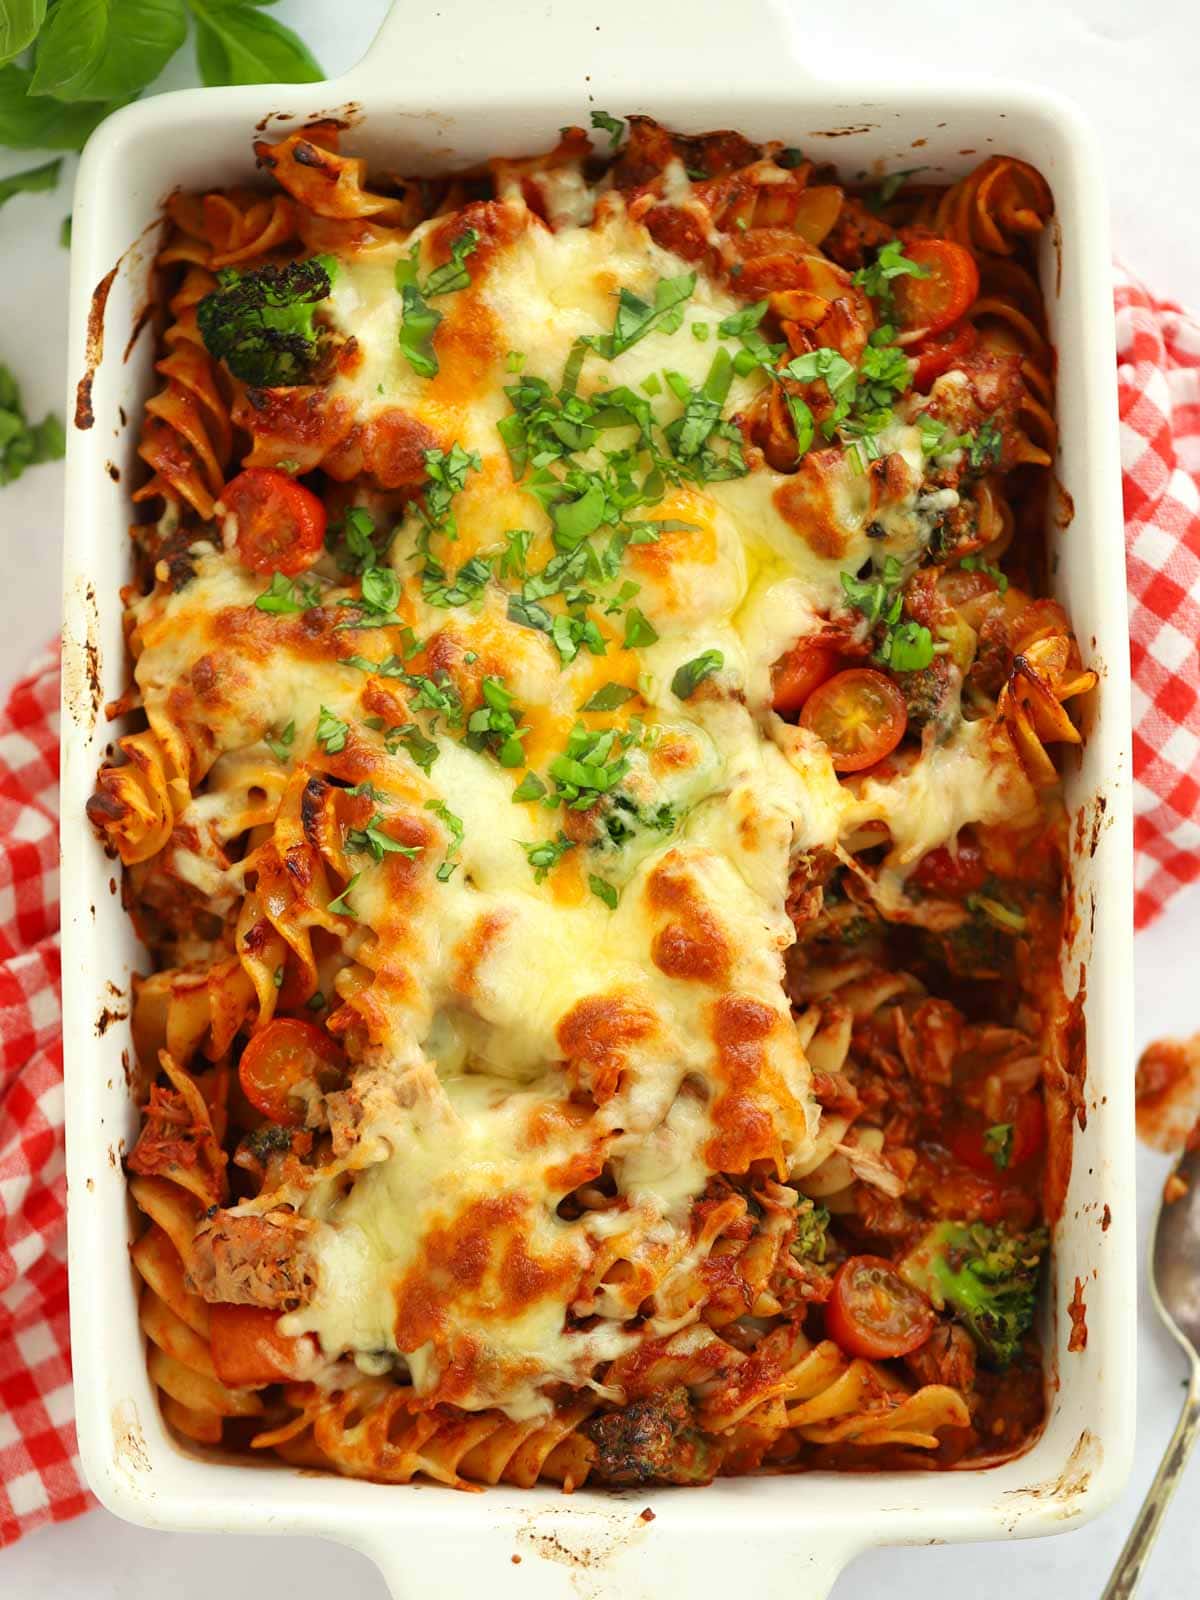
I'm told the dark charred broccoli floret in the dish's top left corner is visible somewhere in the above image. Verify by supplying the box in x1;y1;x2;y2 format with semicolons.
195;256;338;389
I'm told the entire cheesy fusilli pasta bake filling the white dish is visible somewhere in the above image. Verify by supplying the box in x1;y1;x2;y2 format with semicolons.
88;112;1096;1490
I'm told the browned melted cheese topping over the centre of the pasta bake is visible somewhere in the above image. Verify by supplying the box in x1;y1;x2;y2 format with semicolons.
134;190;1035;1418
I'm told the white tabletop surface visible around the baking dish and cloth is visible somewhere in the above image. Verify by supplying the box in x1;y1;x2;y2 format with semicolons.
0;0;1200;1600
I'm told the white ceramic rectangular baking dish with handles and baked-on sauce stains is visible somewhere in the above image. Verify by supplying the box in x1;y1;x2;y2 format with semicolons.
62;0;1136;1600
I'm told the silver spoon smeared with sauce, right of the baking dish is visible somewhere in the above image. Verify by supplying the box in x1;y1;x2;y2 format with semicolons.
1102;1149;1200;1600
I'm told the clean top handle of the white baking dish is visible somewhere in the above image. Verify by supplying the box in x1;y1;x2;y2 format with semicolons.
349;0;803;100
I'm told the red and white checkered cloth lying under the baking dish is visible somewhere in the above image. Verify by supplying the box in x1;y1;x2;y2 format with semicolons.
0;270;1200;1546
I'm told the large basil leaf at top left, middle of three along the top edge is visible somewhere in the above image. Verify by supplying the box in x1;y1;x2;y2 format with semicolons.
30;0;187;102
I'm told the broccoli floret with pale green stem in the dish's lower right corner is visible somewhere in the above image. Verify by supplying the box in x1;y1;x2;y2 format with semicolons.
899;1222;1048;1366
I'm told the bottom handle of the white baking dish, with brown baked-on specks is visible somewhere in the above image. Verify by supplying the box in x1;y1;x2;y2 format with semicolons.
356;1510;869;1600
